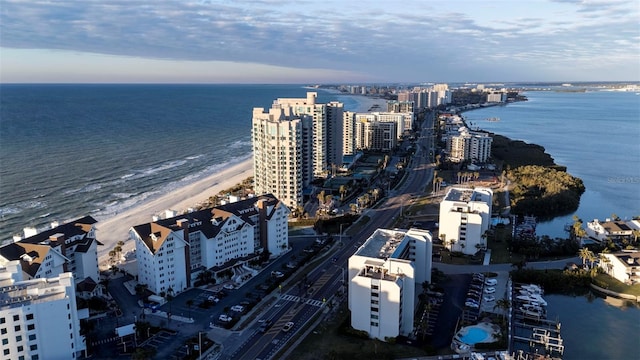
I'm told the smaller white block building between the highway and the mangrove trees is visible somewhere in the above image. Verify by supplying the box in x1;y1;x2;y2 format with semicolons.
439;187;493;255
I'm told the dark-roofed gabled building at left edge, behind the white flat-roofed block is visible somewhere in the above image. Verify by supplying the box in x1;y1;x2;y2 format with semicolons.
0;216;102;290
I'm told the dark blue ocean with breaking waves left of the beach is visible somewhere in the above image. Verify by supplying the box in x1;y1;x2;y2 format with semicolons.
0;84;359;241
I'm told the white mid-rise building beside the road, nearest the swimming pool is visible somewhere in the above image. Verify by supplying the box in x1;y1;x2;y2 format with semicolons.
348;229;432;341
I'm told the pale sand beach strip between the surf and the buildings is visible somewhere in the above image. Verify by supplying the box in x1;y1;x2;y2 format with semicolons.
96;158;253;268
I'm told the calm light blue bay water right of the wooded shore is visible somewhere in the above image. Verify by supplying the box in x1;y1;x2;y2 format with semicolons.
463;91;640;237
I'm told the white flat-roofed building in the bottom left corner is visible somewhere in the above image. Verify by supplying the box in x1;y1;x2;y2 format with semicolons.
0;260;86;360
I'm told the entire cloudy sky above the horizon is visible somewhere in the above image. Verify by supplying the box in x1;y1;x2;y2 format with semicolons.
0;0;640;84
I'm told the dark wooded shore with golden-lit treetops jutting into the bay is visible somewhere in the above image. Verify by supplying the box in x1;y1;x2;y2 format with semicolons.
492;135;585;219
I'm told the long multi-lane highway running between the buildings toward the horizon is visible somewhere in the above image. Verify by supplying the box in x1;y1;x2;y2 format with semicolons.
220;112;434;360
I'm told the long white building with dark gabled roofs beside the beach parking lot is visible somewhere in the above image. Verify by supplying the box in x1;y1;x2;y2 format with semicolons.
129;194;289;294
